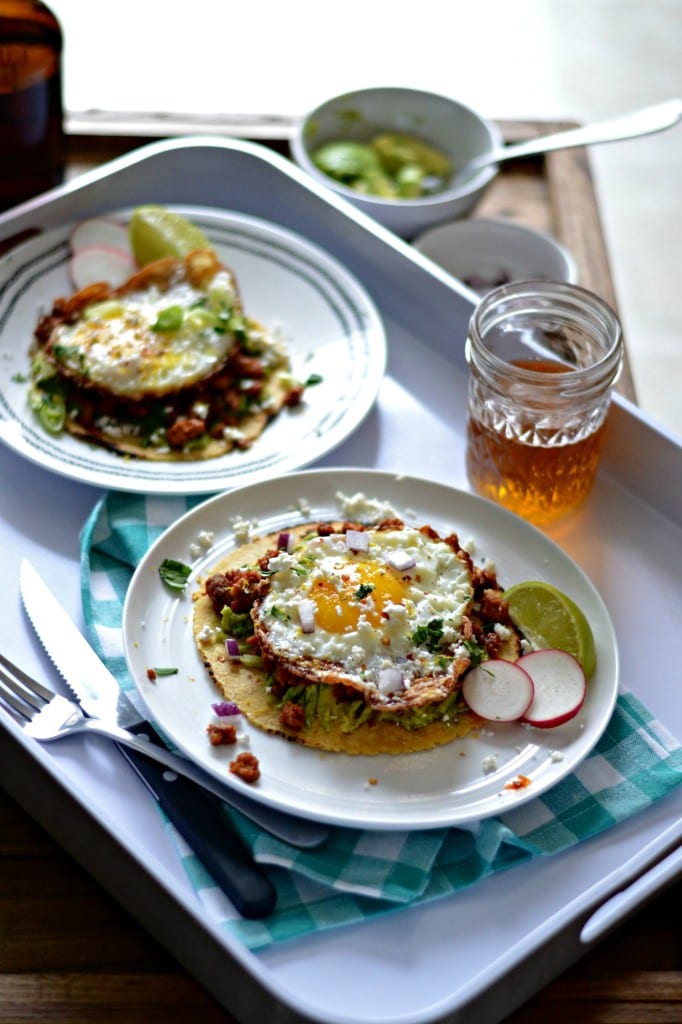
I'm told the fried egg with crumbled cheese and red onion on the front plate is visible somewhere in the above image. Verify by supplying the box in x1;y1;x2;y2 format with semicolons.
254;525;473;702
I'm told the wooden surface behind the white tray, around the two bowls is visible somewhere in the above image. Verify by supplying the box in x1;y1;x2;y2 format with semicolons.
61;117;637;401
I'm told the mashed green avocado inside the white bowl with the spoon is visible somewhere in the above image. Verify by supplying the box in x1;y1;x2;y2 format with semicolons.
312;132;453;199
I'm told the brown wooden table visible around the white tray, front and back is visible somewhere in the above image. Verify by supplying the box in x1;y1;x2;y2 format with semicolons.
0;123;682;1024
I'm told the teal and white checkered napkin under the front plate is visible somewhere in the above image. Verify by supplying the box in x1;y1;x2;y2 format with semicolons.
81;494;682;949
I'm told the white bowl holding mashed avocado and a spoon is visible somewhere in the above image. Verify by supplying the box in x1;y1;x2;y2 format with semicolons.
290;86;503;239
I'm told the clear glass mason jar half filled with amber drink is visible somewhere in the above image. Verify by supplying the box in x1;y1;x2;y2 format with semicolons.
466;281;623;525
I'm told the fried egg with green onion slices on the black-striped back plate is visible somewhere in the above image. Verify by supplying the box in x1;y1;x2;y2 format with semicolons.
49;256;238;400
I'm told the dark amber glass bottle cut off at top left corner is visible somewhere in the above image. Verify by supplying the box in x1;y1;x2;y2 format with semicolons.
0;0;65;210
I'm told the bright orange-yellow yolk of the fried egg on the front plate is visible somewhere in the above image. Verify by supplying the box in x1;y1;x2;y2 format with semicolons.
310;564;404;633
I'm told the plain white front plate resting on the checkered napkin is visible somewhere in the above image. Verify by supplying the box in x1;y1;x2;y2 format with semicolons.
123;469;619;828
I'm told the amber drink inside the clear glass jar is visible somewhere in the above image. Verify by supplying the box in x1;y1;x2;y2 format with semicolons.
467;359;604;525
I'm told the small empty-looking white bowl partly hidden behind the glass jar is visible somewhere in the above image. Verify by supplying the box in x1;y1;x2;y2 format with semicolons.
414;217;578;295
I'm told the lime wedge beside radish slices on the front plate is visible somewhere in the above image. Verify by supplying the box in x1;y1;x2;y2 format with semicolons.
504;580;597;679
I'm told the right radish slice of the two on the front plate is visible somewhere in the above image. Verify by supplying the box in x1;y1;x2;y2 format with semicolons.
517;649;587;729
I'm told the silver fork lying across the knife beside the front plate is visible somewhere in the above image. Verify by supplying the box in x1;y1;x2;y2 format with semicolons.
0;654;327;847
